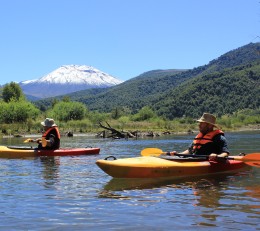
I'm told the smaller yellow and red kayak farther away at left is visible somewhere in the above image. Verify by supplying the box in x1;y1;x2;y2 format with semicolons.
0;146;100;158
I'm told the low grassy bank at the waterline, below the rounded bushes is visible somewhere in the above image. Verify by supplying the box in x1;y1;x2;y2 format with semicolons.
0;115;260;137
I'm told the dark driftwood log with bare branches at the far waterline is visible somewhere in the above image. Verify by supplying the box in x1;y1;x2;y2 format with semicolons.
98;122;136;139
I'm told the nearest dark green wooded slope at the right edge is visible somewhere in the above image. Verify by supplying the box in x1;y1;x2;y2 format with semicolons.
152;61;260;119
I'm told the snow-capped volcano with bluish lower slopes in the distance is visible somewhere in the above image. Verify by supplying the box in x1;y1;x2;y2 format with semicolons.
19;65;122;98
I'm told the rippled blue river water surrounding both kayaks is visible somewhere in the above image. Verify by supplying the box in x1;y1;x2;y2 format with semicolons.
0;131;260;231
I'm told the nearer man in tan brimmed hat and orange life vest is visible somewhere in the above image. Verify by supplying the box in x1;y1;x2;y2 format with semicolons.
170;113;229;160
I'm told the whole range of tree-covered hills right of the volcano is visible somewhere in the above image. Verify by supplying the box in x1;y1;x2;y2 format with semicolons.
37;43;260;118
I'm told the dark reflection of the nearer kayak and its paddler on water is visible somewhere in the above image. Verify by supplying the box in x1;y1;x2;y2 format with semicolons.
99;170;254;208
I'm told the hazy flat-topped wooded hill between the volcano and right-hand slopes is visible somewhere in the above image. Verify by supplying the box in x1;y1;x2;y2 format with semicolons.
36;70;191;112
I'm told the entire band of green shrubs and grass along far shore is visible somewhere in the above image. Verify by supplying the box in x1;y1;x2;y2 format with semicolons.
0;82;260;137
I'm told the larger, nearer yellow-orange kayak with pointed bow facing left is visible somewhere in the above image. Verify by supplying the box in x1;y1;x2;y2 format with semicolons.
96;156;248;178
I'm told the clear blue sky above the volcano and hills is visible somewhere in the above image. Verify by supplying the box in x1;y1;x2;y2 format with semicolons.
0;0;260;84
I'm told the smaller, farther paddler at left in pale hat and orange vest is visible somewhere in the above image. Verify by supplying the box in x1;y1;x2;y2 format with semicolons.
35;118;60;150
